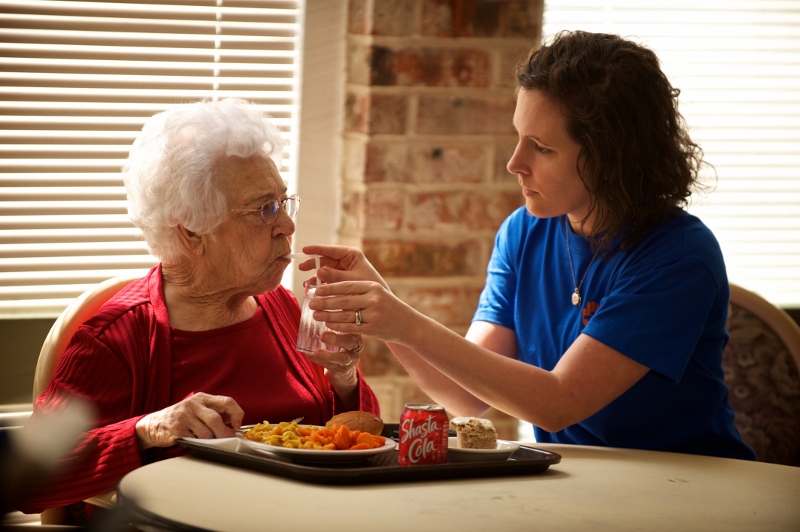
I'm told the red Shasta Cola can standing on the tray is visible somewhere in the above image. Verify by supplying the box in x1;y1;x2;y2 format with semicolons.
397;403;450;466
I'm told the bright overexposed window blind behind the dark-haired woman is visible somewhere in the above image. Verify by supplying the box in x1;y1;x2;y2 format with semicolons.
543;0;800;308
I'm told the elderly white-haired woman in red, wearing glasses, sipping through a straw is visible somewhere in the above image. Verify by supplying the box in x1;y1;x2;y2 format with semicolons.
20;99;379;512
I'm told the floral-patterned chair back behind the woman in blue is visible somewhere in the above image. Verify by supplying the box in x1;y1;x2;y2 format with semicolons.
723;285;800;466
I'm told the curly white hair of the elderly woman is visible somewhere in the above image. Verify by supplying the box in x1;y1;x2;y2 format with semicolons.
123;98;283;262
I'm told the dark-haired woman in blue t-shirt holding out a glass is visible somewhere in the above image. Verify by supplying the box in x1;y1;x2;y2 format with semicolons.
304;32;754;459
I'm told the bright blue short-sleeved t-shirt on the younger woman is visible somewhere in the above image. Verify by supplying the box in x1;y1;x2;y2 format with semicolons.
473;207;755;460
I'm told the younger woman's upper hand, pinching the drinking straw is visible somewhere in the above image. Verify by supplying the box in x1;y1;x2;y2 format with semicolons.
298;245;389;290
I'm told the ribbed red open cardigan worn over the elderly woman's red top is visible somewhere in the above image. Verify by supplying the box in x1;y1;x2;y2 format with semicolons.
18;265;380;513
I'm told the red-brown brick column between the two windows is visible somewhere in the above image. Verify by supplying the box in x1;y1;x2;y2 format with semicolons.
339;0;542;438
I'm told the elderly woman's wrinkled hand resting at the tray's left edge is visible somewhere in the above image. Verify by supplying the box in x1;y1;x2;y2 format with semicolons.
136;393;244;450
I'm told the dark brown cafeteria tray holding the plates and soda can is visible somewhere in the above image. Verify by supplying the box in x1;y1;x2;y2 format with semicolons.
179;428;561;485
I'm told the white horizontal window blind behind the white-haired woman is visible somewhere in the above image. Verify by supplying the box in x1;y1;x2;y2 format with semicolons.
0;0;300;318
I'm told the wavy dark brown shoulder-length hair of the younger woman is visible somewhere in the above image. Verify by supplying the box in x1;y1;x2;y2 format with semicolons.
516;31;703;255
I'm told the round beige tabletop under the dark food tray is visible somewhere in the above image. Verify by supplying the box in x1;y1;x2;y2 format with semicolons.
119;444;800;532
